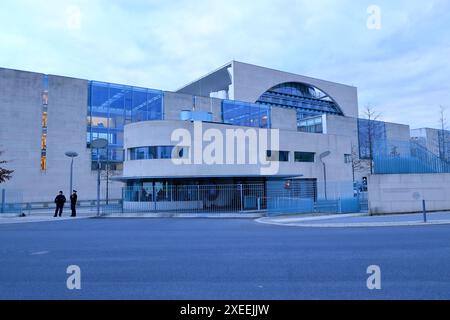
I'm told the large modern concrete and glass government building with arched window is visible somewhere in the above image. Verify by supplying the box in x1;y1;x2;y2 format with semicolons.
0;61;444;214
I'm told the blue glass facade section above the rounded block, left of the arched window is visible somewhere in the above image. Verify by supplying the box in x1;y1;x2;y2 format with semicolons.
222;100;271;129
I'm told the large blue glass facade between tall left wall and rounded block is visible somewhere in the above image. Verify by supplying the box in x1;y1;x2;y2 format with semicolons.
86;81;163;170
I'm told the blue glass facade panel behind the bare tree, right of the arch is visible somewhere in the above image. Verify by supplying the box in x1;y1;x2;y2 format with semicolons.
358;119;387;159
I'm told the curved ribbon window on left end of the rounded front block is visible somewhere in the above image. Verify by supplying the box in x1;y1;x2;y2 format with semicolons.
129;146;189;160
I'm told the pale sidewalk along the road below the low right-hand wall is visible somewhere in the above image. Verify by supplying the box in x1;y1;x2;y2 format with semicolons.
256;212;450;228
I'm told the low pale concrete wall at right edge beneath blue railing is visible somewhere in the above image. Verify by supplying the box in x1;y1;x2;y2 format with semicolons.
369;174;450;214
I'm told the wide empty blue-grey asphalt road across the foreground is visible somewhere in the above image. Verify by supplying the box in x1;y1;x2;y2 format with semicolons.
0;219;450;300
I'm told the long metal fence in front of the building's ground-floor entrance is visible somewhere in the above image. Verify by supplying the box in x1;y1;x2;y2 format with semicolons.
117;179;361;215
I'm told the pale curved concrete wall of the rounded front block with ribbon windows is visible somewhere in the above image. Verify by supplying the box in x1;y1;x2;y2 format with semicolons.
124;121;352;200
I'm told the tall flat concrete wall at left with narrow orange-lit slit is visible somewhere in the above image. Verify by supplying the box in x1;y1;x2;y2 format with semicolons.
0;69;123;202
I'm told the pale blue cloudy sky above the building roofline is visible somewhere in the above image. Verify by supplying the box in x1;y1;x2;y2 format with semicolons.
0;0;450;128
